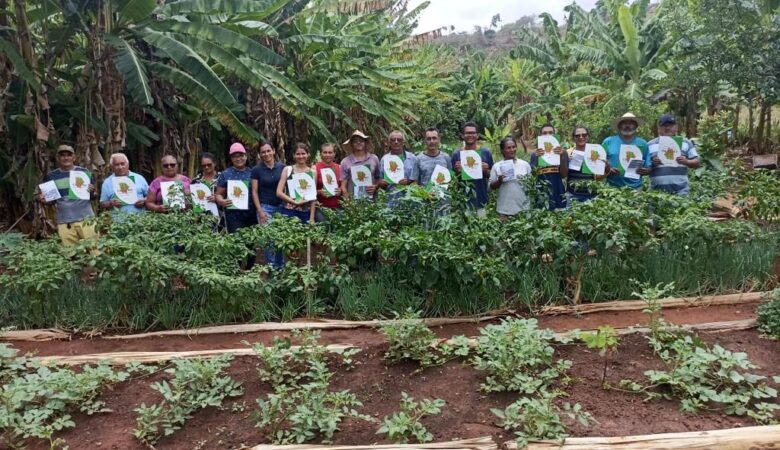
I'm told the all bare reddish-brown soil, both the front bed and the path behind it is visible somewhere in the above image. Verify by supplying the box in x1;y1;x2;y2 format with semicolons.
7;305;780;450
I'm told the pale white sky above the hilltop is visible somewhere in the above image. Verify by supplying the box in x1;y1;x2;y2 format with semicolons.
409;0;596;33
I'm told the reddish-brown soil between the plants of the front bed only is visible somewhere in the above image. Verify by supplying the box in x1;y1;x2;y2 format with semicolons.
21;331;780;450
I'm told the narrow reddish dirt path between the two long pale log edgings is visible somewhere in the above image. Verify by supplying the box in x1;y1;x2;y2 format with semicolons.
0;304;757;356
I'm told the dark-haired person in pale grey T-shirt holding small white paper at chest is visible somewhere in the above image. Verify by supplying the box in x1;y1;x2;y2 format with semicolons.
490;137;531;221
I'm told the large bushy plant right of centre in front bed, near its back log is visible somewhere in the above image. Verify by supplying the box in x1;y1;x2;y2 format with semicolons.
472;319;571;395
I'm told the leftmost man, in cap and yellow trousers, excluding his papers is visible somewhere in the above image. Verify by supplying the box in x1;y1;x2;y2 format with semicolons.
38;145;97;246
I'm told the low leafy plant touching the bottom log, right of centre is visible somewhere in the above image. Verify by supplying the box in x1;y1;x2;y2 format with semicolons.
491;395;594;448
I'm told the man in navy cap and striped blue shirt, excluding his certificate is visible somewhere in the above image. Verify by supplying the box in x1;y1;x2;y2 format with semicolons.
647;114;701;196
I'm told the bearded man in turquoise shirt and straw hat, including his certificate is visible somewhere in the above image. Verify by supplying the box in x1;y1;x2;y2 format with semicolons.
601;112;652;189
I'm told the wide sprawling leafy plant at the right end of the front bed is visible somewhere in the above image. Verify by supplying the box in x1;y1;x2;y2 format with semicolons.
621;331;780;424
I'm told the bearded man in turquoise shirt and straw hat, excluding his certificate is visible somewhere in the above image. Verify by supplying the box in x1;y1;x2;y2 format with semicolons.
601;112;651;189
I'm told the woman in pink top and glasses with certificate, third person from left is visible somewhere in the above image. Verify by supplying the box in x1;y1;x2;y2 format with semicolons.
146;155;190;213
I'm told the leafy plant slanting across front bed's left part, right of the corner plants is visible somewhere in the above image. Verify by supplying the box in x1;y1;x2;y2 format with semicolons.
133;355;244;446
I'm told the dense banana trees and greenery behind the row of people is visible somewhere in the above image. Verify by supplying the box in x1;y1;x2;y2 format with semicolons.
0;0;780;234
